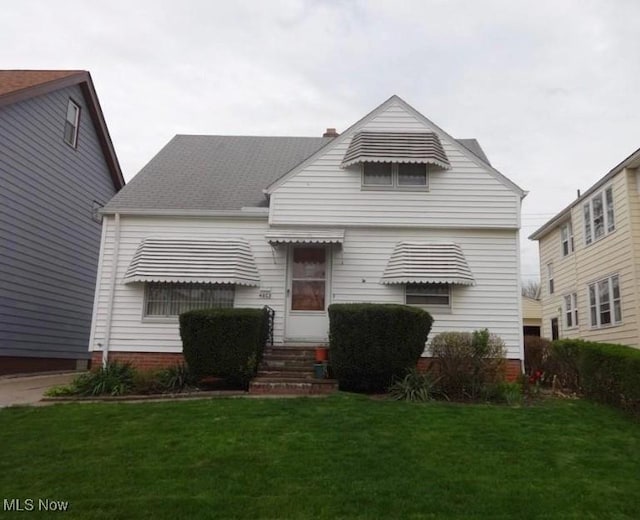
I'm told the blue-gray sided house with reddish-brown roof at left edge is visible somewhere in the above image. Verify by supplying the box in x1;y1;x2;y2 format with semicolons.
0;70;124;374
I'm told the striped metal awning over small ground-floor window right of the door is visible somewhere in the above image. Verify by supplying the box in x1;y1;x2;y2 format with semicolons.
381;242;475;285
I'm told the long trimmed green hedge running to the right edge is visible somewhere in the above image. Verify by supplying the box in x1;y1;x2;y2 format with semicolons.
576;341;640;416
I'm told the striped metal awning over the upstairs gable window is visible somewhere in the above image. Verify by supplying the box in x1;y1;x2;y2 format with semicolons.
342;132;451;169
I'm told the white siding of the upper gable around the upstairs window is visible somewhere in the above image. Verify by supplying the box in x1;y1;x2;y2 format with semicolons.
269;104;520;229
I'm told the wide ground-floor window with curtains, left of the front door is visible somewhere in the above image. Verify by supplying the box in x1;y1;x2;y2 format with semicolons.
144;283;234;317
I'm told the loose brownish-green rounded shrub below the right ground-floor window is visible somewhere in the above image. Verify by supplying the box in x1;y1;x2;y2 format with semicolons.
430;329;506;399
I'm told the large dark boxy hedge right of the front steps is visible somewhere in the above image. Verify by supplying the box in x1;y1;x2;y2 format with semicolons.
329;303;433;392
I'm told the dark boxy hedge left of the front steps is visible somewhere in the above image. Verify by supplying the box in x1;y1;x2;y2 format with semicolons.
180;308;268;388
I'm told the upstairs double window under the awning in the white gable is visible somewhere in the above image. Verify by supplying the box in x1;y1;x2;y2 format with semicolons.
362;162;429;190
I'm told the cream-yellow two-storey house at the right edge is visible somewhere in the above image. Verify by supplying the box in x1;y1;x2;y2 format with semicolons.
530;150;640;347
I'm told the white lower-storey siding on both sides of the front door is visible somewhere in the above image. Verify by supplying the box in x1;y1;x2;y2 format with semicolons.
91;216;522;358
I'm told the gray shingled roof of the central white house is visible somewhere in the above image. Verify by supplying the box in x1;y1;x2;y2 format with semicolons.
105;135;488;211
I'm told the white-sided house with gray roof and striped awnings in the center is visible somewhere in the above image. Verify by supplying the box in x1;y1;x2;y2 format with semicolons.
90;96;524;376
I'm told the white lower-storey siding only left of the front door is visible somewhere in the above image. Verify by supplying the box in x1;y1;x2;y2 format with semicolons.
89;216;286;352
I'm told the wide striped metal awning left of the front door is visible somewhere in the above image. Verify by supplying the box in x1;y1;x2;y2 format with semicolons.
124;238;260;285
